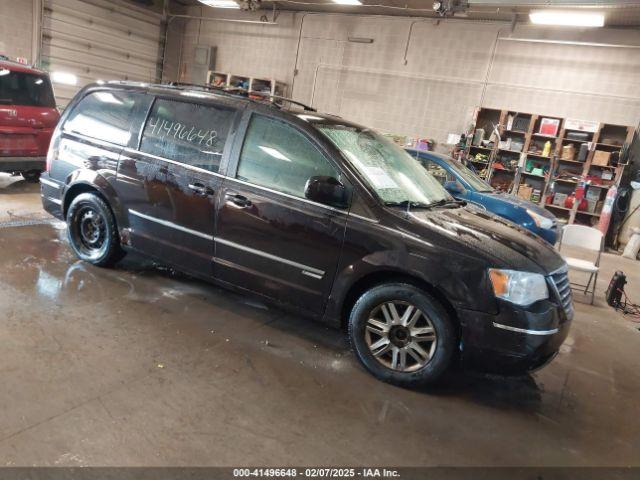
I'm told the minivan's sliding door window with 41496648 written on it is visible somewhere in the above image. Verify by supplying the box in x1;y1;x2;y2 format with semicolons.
140;99;235;172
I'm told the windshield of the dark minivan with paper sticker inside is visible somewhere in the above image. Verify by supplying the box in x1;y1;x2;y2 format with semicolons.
315;123;453;207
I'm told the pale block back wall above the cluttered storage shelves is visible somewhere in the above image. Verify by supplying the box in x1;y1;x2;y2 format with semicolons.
170;8;640;150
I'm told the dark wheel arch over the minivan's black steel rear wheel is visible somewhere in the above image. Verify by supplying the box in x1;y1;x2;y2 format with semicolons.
62;169;129;231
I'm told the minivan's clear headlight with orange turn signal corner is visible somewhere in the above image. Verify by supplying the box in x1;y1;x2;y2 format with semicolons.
489;268;549;307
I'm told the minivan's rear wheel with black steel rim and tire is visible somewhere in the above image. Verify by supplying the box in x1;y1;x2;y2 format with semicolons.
67;193;125;267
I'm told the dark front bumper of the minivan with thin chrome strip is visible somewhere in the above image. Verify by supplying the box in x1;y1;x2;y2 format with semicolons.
459;300;572;374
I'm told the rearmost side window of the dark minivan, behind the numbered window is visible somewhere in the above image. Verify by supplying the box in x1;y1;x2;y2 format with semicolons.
64;91;142;146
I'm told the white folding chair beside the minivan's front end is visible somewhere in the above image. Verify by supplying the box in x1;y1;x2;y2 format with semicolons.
558;225;604;305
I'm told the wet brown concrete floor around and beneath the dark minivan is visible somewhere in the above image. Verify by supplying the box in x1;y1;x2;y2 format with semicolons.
0;174;640;466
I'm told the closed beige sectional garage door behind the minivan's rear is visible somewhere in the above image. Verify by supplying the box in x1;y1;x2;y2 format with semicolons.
42;0;162;107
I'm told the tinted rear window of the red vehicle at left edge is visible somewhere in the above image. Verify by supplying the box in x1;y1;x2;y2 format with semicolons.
0;67;56;108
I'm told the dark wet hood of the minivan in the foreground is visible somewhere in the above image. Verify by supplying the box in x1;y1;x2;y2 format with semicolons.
405;207;565;275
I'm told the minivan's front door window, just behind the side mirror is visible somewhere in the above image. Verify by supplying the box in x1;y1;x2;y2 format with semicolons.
237;115;338;198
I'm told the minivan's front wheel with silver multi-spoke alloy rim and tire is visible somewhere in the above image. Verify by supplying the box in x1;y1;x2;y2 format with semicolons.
349;283;457;387
